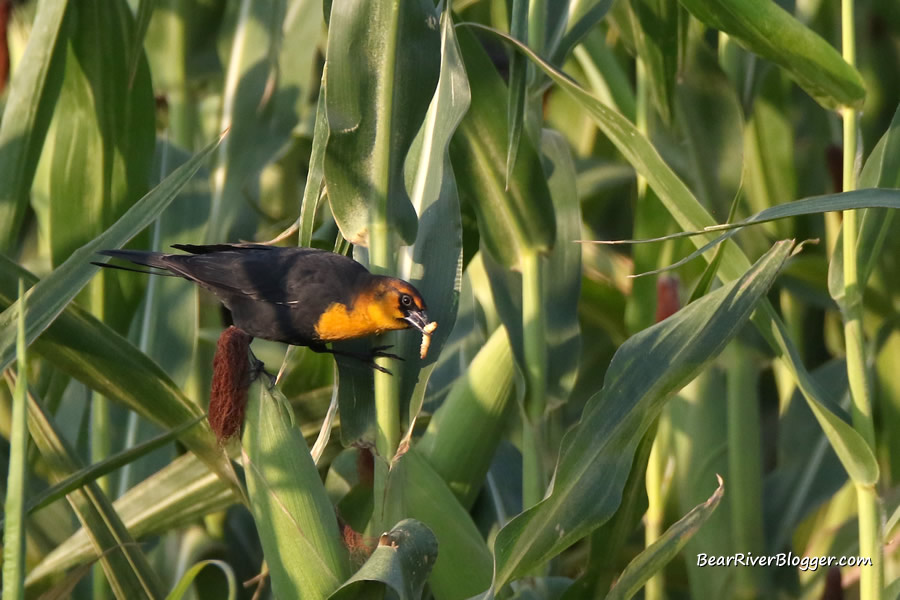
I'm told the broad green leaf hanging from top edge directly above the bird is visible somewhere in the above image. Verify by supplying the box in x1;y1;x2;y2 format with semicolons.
324;0;440;245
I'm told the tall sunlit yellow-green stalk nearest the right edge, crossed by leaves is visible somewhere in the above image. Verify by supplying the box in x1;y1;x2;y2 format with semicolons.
841;0;884;600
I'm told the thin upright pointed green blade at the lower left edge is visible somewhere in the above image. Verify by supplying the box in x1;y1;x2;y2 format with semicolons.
3;279;28;600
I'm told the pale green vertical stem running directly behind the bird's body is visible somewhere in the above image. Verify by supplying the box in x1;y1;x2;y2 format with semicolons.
369;0;401;529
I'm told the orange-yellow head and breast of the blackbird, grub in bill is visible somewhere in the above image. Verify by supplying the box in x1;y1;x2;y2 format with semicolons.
316;275;429;341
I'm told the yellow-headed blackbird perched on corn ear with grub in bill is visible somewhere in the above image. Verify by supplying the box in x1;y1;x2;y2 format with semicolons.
94;244;434;371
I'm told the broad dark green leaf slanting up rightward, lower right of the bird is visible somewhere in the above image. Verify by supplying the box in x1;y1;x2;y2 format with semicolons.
493;242;793;591
